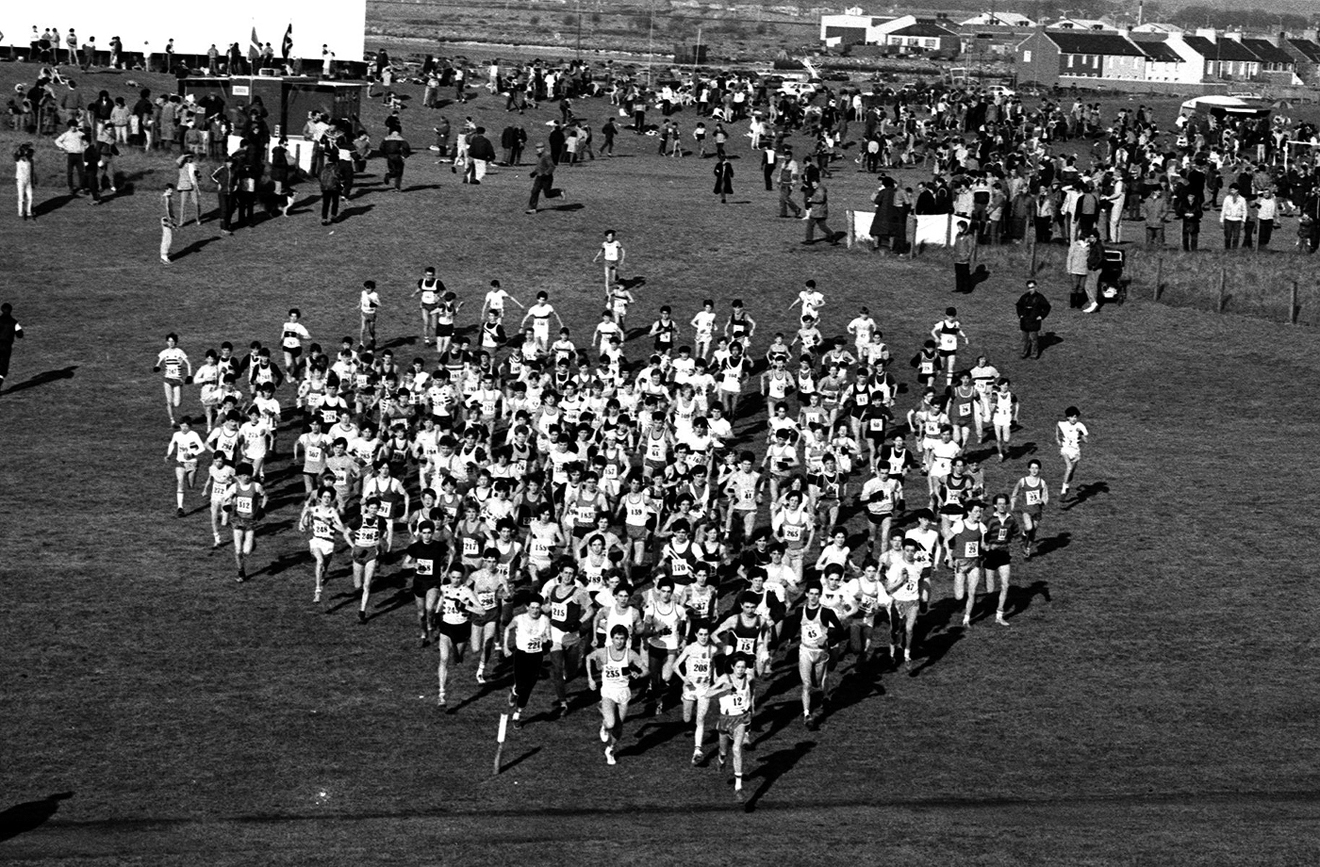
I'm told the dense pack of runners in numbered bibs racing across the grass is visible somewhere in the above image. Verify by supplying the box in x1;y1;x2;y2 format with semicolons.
156;231;1088;797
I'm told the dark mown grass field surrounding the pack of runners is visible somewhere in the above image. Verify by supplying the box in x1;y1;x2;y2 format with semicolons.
0;62;1320;864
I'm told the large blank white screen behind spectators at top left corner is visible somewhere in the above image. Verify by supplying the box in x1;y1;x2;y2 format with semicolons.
0;0;367;61
